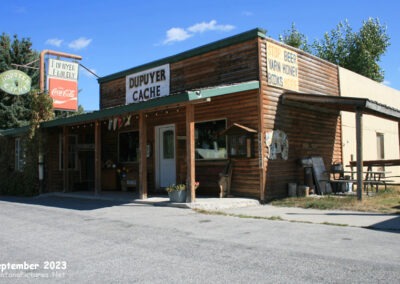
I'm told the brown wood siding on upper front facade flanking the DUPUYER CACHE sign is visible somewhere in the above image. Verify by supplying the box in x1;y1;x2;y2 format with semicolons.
100;39;258;109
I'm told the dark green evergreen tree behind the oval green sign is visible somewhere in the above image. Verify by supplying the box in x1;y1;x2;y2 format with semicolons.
0;33;39;129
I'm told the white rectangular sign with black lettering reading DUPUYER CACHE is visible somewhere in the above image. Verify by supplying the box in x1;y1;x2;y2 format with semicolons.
126;64;170;104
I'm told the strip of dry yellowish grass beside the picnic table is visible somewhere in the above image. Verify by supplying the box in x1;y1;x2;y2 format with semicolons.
270;186;400;214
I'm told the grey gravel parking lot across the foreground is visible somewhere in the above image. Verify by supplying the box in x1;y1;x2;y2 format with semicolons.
0;197;400;283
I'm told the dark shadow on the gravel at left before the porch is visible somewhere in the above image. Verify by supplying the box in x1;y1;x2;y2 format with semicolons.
0;196;130;210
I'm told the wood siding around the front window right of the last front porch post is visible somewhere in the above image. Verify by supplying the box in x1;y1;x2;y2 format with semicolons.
195;90;260;198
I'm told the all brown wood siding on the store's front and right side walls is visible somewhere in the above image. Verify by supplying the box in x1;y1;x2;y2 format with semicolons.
43;33;342;199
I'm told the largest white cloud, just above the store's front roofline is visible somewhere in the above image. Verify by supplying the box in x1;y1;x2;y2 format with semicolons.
163;20;235;44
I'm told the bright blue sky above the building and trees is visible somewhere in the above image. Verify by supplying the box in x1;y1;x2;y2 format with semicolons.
0;0;400;110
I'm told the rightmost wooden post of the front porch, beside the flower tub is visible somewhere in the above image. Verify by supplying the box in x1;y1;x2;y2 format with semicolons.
186;104;196;202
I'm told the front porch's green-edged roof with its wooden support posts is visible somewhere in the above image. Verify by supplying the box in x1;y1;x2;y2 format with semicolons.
41;81;259;203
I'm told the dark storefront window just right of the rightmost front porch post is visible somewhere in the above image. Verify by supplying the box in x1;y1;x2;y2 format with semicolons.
195;119;226;160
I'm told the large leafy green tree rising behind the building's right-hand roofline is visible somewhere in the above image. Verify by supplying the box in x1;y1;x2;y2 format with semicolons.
313;18;390;82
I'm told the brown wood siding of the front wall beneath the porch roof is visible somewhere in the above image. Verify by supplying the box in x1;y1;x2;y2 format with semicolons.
97;90;259;197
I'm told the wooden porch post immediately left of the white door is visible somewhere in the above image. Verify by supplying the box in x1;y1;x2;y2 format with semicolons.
139;112;147;199
